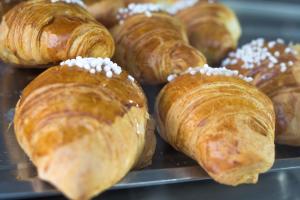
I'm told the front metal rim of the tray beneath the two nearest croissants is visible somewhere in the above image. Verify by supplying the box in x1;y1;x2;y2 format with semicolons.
0;157;300;199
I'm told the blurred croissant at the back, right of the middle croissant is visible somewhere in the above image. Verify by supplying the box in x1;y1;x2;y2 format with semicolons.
176;1;241;65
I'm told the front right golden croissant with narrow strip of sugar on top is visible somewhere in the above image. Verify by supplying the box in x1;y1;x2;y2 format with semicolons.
155;66;275;186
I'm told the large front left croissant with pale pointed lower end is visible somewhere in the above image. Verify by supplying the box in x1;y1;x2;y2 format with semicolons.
14;57;155;199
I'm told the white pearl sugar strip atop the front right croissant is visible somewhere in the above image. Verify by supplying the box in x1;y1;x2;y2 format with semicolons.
168;64;253;82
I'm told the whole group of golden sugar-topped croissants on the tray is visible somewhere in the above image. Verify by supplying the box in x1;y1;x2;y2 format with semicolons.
0;0;300;199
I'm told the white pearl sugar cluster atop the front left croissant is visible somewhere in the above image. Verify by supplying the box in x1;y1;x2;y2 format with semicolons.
60;56;134;81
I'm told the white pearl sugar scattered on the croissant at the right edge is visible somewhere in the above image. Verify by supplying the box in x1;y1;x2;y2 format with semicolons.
222;38;297;72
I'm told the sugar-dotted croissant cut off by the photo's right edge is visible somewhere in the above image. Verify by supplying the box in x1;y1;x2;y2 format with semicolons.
223;38;300;146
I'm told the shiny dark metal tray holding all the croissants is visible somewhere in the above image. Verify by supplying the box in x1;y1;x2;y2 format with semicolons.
0;0;300;199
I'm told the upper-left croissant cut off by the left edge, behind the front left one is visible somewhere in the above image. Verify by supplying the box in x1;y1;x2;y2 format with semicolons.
0;0;114;66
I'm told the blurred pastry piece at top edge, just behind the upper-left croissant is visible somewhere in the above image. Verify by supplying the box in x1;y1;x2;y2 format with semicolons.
84;0;124;28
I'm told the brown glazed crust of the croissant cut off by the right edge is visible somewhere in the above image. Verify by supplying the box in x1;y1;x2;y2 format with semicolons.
228;41;300;146
